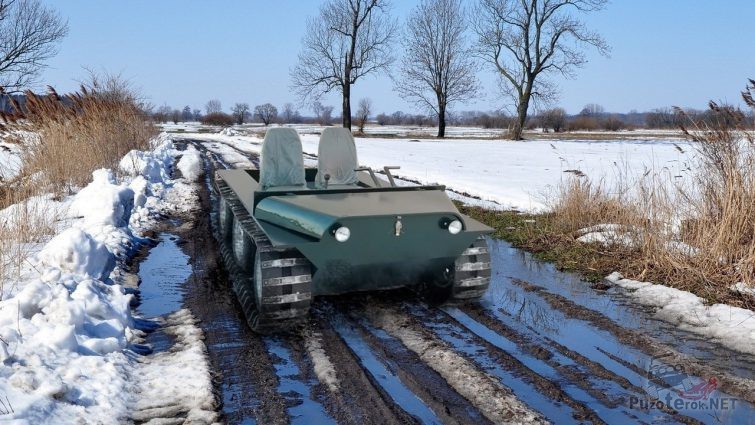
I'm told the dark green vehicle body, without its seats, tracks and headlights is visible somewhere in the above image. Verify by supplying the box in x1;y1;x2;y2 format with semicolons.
218;169;492;295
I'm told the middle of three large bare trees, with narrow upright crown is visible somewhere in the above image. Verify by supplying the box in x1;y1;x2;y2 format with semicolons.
396;0;477;137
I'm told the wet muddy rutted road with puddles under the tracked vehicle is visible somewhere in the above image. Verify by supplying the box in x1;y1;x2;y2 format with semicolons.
145;140;755;424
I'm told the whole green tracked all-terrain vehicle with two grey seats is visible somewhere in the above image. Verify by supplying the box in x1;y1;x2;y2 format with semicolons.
215;128;492;332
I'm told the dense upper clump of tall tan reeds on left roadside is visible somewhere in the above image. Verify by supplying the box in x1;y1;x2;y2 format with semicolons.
2;76;157;194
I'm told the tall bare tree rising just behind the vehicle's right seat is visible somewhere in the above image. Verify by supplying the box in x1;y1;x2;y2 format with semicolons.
291;0;396;129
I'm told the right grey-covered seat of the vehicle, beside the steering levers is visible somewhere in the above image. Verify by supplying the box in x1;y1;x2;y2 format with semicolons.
315;127;359;187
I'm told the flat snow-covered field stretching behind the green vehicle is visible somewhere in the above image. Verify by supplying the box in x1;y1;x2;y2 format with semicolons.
181;126;692;211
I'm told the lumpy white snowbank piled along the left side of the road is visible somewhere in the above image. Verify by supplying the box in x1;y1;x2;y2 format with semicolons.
0;138;215;424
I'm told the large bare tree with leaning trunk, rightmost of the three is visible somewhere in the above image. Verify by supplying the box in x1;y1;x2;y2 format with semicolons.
473;0;609;140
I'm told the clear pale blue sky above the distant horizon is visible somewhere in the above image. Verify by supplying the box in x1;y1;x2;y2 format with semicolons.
41;0;755;114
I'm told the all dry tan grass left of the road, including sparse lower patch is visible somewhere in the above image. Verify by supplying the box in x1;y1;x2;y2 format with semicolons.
0;74;157;296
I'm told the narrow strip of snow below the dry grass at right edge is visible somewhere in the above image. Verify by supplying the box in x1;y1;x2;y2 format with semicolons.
606;272;755;354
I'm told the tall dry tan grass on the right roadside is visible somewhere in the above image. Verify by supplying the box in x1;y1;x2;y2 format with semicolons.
549;81;755;305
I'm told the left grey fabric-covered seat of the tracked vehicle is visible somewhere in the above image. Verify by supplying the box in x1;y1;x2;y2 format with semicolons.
260;128;306;190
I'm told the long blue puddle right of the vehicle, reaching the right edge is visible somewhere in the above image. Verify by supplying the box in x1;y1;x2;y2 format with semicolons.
484;240;755;423
